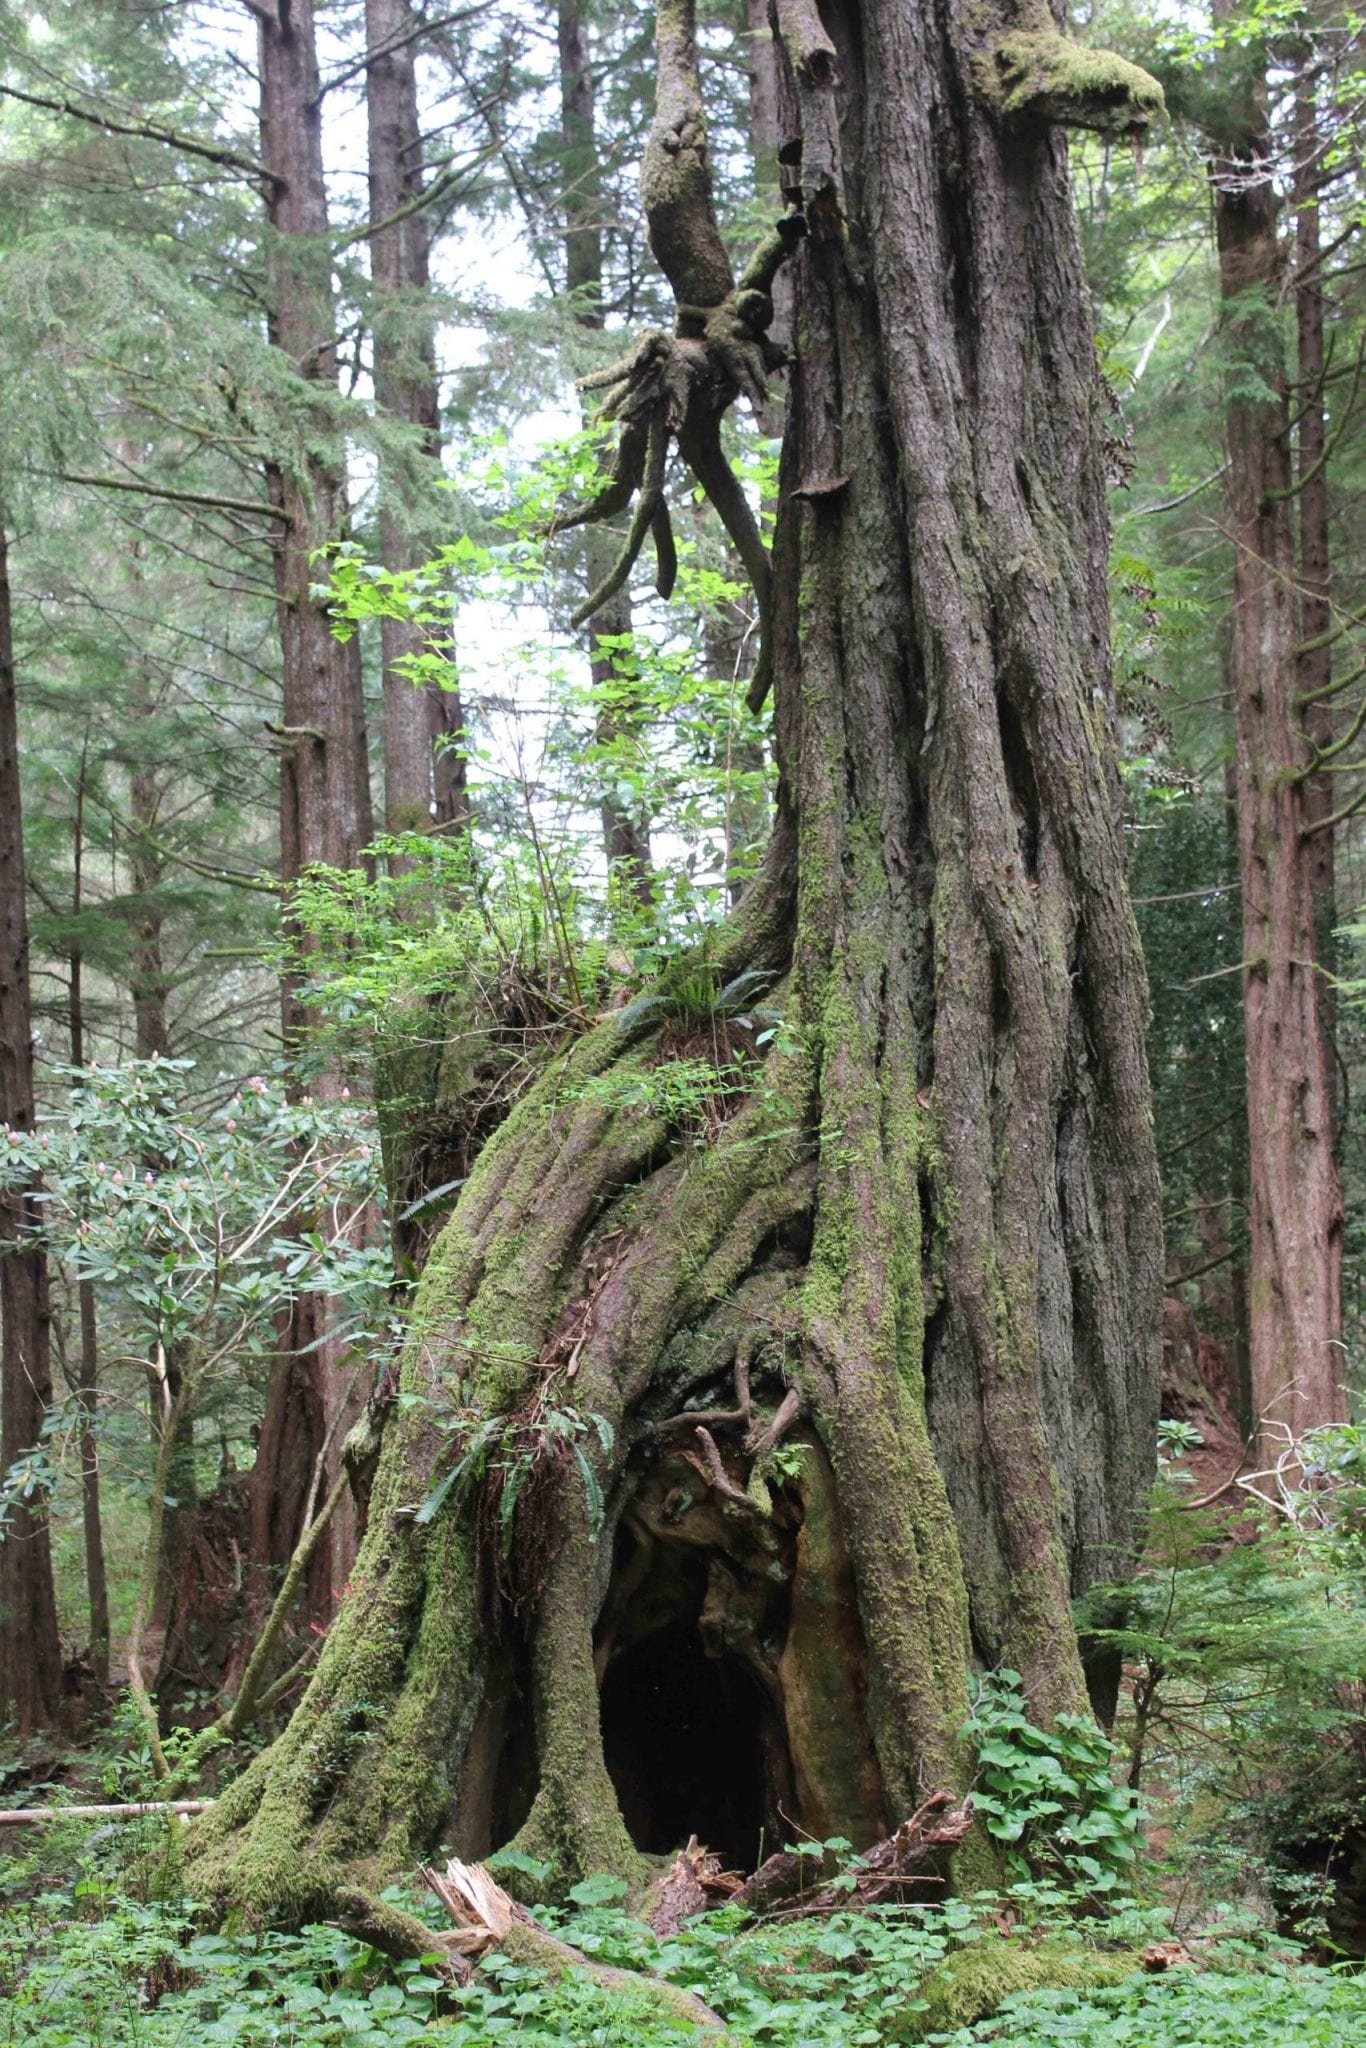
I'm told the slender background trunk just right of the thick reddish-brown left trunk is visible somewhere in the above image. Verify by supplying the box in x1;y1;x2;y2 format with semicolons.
365;0;469;847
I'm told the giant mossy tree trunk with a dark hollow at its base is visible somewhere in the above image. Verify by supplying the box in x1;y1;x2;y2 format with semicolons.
190;0;1161;1915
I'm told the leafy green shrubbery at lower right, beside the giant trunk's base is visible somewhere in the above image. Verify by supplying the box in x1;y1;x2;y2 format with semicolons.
1079;1427;1366;1948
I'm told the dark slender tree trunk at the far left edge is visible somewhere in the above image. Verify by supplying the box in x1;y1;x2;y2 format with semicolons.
0;507;61;1735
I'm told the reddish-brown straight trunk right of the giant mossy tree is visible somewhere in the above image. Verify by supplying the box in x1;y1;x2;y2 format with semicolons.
1212;51;1346;1460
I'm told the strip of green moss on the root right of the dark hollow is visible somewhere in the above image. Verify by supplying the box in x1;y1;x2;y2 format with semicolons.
801;888;969;1812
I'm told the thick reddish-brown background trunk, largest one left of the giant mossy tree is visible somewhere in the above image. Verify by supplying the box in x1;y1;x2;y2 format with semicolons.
252;0;373;1620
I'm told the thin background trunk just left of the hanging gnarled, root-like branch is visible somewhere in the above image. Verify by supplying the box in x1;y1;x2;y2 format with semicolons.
559;0;653;911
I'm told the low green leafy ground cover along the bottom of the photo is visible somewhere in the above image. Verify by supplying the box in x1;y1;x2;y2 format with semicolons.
0;1823;1366;2048
